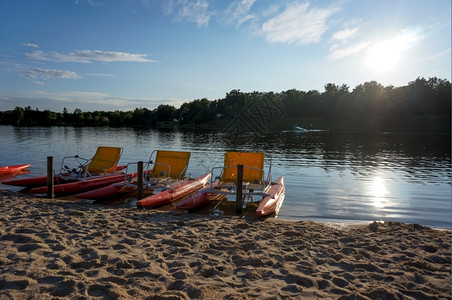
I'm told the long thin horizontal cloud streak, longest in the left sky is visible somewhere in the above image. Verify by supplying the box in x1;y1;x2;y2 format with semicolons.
26;50;156;63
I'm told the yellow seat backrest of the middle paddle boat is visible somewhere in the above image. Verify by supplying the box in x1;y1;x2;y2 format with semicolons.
152;150;190;179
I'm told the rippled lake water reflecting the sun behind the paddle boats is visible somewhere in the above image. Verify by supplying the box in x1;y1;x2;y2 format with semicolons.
0;126;452;228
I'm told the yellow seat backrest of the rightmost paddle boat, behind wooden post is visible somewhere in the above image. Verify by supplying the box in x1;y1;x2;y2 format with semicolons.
221;152;264;182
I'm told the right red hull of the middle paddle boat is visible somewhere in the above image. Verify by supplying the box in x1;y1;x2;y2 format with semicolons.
137;173;212;207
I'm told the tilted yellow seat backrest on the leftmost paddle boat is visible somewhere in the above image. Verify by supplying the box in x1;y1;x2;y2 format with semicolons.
88;146;122;174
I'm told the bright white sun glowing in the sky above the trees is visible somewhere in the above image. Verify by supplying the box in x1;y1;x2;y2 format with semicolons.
367;39;403;73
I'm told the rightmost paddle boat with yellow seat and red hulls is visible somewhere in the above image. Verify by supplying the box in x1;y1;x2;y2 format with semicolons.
176;152;285;216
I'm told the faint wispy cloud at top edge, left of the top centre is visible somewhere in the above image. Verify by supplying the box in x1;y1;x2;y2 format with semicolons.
164;0;215;27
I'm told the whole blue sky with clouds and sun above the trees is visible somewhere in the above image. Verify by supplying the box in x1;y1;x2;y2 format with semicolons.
0;0;451;112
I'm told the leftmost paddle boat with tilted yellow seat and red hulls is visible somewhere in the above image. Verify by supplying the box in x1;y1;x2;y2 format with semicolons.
2;146;126;194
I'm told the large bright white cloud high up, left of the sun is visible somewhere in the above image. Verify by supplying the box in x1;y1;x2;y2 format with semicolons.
261;2;338;44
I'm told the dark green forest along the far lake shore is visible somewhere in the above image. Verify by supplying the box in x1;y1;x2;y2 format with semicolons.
0;77;451;133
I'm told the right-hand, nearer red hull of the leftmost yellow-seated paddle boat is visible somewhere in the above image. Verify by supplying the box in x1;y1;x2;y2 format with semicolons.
30;174;125;194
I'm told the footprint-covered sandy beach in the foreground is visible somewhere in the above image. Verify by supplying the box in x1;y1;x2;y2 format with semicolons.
0;191;451;300
